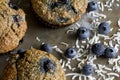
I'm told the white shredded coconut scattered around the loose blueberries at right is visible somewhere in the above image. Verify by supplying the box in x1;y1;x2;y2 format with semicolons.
62;0;120;80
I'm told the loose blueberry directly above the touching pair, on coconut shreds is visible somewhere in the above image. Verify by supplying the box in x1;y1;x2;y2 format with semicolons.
98;22;110;34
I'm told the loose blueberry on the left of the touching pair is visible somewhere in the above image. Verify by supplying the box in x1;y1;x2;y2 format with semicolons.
92;43;105;56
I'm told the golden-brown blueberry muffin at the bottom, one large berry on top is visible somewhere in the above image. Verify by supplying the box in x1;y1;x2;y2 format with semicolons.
0;49;66;80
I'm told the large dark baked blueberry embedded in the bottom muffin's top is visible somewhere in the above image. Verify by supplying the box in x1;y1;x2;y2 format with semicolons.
39;58;56;73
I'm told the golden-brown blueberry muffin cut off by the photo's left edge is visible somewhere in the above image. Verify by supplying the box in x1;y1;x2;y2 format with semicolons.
0;0;27;54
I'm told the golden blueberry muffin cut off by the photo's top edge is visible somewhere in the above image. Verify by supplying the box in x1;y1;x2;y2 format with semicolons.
31;0;88;27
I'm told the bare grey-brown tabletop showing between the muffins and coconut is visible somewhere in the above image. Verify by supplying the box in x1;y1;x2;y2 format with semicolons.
0;0;120;80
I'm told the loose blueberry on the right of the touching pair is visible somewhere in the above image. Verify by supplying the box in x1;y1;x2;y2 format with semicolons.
104;47;117;58
